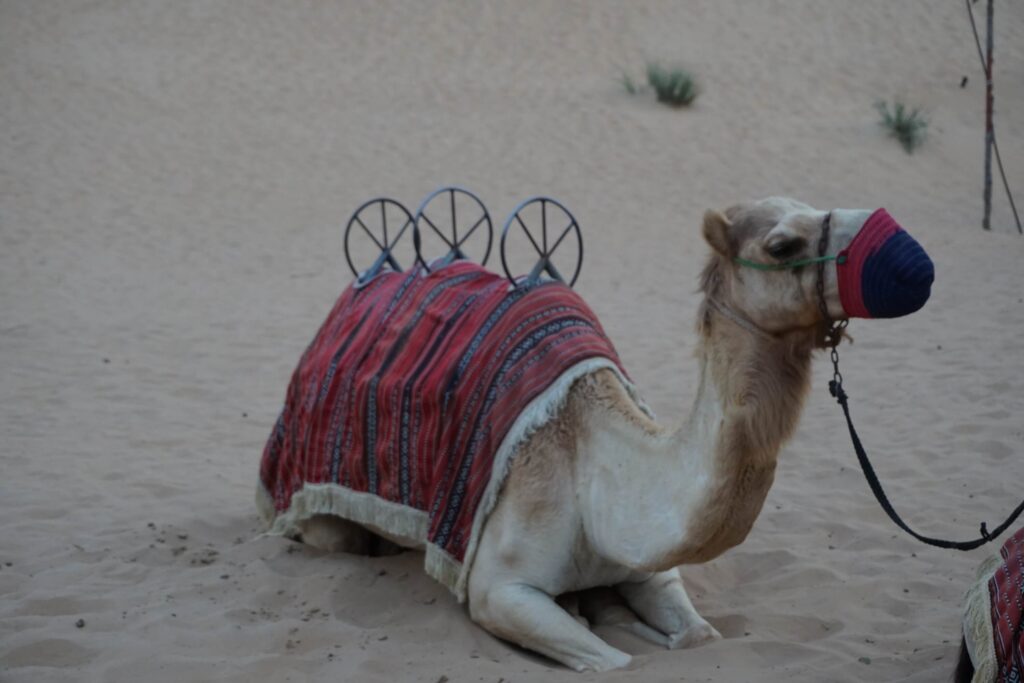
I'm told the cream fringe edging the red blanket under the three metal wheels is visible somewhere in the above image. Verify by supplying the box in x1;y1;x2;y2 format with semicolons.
256;357;654;602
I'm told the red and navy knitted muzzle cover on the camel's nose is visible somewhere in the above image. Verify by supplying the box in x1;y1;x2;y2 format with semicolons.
836;209;935;317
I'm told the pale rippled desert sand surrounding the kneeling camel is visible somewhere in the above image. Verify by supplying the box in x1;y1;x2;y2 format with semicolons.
0;0;1024;683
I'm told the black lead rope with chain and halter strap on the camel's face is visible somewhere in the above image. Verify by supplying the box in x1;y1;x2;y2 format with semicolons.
817;212;1024;551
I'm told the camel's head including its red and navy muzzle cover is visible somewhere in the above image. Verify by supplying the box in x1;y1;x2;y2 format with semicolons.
702;197;935;335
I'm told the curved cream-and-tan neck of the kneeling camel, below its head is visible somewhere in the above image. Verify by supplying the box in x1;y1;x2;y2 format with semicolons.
577;311;812;571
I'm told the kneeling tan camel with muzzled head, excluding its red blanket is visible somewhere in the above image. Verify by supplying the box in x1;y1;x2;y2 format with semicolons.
263;198;933;672
